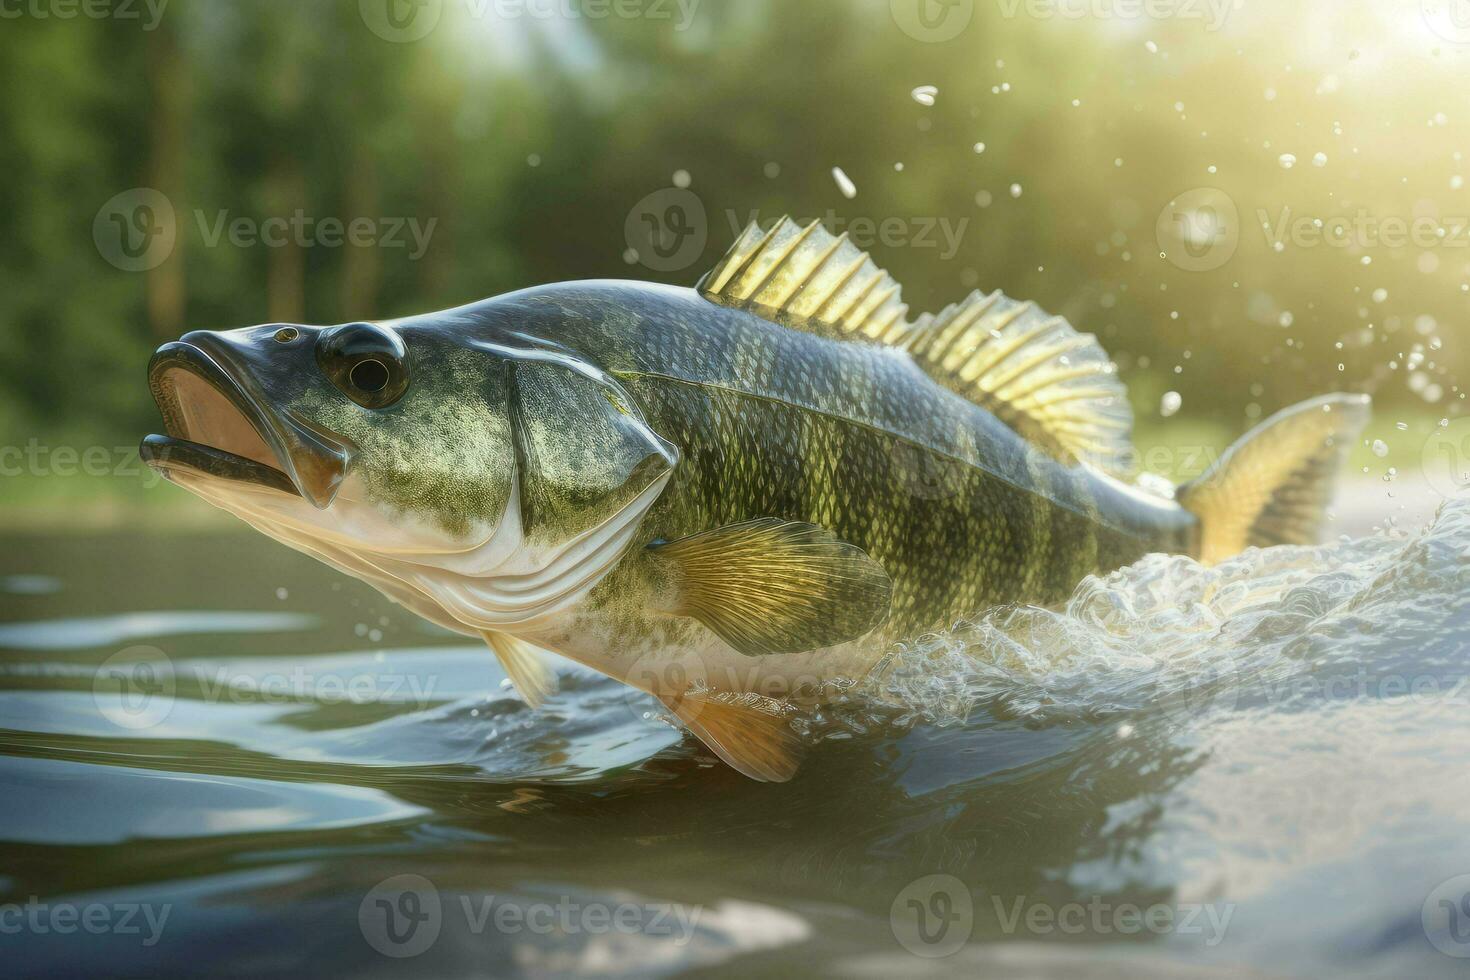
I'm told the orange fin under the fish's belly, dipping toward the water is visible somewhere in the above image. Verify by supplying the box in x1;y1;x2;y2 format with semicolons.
660;695;801;783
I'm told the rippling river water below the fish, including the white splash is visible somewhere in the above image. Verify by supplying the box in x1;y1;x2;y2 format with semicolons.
0;487;1470;977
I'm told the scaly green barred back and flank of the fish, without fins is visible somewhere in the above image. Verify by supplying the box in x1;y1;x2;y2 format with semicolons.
497;282;1194;639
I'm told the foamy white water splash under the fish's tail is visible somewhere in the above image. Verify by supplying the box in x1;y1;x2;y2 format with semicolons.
810;498;1470;733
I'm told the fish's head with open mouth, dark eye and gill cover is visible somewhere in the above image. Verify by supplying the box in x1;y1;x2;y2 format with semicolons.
141;317;678;633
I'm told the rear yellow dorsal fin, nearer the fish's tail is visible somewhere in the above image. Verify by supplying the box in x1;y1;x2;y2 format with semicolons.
903;291;1135;478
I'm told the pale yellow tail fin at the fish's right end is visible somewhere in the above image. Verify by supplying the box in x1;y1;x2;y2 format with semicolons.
1179;395;1373;564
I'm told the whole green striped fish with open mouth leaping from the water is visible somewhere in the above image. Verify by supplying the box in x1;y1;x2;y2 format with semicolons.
140;217;1372;782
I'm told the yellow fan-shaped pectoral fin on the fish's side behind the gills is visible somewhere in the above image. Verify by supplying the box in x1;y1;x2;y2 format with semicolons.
650;517;892;657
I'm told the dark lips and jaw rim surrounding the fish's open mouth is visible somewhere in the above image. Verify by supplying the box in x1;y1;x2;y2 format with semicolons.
138;335;353;508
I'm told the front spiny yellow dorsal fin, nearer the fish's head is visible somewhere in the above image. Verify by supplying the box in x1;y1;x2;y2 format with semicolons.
697;216;908;342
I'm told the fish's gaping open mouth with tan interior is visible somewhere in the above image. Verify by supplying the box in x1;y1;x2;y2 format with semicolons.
138;341;306;497
